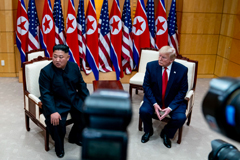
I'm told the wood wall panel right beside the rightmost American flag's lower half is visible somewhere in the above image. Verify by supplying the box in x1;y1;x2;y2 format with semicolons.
180;34;219;55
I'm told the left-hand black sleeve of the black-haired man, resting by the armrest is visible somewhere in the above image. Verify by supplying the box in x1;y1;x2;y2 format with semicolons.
39;69;57;114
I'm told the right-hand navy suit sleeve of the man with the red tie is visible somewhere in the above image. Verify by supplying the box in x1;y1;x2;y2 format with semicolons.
169;68;188;110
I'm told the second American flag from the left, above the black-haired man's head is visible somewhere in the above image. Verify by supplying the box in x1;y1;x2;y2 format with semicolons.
53;0;66;44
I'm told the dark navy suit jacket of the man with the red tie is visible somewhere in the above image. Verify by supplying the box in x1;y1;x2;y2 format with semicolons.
143;61;188;112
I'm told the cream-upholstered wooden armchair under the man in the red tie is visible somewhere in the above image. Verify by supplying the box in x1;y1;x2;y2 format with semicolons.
138;51;198;144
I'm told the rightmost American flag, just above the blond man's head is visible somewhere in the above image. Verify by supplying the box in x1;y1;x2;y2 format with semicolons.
168;0;179;55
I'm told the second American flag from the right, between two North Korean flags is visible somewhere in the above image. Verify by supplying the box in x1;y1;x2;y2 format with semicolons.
146;0;155;48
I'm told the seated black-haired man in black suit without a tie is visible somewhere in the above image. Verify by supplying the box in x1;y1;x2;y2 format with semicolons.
39;45;89;158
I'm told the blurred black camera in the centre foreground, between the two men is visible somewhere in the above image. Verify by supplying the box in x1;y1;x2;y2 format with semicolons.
82;90;132;160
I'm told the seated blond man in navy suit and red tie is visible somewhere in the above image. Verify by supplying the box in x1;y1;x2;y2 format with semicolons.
140;46;188;148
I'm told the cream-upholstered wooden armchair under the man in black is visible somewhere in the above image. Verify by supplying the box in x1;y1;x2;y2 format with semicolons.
22;56;72;151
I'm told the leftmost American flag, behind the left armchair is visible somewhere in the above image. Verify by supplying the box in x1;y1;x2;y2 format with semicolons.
28;0;40;51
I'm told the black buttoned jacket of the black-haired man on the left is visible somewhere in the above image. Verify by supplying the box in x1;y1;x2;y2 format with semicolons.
39;61;89;117
